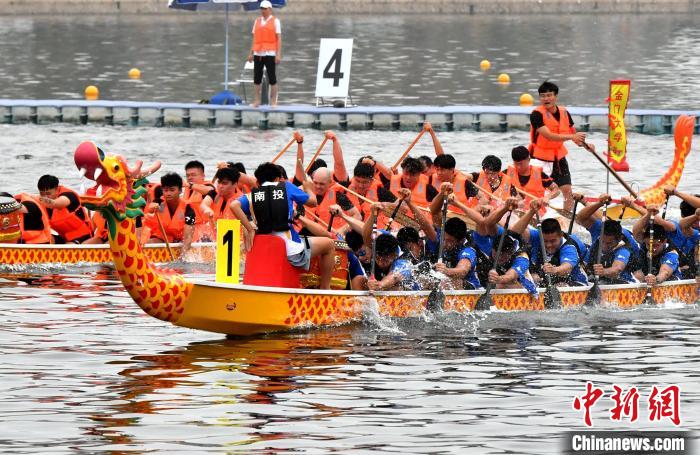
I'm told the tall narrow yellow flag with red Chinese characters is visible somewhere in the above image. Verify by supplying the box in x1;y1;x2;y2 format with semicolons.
608;80;630;172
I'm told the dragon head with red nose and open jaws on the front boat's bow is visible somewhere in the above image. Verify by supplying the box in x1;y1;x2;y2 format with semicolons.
74;141;151;234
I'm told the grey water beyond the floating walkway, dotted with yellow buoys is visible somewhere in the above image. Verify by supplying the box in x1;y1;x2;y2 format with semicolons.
0;13;700;110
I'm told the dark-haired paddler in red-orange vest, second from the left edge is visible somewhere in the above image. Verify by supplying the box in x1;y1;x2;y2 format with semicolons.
37;175;92;243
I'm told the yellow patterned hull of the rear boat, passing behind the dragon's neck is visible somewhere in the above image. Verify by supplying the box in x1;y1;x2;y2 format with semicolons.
0;243;216;266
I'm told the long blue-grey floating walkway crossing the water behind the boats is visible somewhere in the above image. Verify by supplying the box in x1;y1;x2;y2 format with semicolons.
0;99;700;134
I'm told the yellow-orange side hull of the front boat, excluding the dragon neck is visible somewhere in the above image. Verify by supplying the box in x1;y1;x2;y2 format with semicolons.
172;280;698;336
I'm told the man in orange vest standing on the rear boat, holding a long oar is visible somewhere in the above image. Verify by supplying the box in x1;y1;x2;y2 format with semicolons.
529;81;586;210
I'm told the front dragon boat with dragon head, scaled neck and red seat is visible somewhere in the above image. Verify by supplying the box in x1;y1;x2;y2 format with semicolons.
75;116;698;336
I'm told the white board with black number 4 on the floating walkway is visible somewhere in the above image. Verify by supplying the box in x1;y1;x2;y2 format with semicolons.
316;38;353;98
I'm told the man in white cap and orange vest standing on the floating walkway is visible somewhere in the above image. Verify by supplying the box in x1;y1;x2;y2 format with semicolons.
248;0;282;107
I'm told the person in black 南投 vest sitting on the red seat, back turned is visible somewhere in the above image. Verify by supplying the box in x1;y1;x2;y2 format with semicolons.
231;163;335;289
